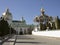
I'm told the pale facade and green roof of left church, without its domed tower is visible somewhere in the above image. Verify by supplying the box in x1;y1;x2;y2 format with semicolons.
12;22;30;34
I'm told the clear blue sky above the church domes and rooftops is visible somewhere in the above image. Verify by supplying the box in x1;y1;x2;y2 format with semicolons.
0;0;60;24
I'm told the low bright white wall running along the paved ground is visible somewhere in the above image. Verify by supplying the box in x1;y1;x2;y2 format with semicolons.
32;30;60;37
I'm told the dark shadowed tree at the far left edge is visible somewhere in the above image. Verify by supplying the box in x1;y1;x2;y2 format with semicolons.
0;19;9;36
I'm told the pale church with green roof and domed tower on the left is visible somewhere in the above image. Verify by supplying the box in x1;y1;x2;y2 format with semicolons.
2;9;33;34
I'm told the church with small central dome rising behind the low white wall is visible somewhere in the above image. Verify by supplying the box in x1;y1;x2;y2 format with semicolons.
34;8;57;30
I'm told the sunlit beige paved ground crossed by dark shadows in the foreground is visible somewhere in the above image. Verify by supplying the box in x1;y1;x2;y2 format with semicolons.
3;35;60;45
